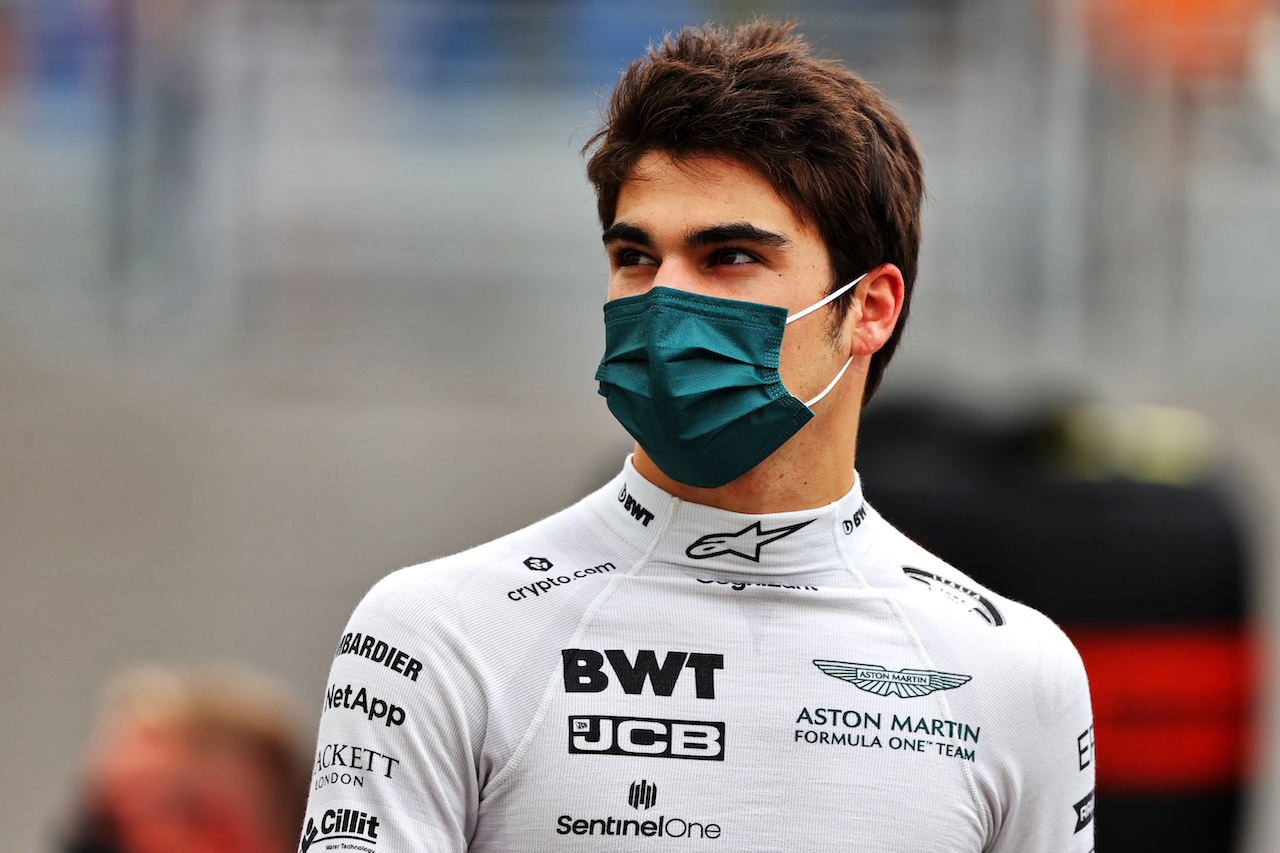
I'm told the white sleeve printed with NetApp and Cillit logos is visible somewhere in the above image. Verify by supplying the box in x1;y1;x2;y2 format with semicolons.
300;575;485;853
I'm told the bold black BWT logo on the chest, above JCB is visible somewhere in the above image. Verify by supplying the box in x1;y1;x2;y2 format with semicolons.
561;648;724;699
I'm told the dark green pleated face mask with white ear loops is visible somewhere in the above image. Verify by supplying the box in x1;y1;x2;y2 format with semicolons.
595;275;863;488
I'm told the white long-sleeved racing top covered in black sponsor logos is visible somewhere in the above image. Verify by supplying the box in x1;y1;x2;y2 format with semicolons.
301;462;1094;853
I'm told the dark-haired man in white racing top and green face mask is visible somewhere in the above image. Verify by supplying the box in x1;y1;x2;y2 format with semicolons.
302;22;1093;853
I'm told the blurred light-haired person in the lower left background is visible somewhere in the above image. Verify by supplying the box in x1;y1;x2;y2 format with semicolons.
63;666;307;853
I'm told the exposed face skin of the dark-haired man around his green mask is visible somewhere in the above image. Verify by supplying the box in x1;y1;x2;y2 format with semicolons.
604;152;849;411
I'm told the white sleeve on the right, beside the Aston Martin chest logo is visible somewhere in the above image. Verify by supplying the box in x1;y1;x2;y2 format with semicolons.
987;620;1094;853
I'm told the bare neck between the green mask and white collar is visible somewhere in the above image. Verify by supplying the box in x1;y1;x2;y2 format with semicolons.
634;394;860;515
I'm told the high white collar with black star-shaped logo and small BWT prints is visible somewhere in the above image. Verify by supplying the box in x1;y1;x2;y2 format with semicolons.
589;457;883;581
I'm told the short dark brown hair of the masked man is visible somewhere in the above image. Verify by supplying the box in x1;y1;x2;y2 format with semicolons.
584;20;924;402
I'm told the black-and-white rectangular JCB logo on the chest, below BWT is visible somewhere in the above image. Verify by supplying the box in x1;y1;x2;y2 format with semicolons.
568;716;724;761
